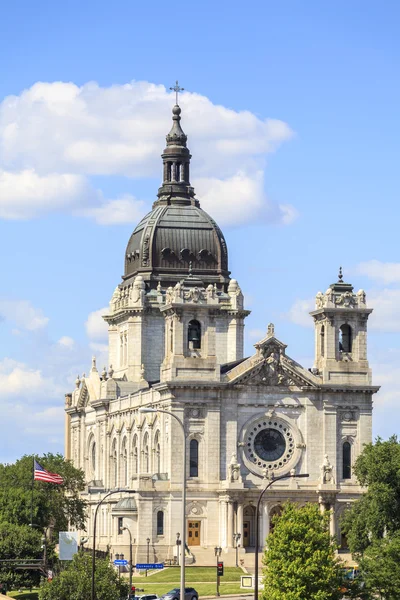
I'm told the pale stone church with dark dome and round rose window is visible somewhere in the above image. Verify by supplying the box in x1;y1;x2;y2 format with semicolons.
65;99;378;565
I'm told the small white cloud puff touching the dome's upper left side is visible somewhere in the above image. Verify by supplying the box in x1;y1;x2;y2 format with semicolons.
80;195;146;225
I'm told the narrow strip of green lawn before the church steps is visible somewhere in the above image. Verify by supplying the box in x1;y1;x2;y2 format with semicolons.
133;567;243;587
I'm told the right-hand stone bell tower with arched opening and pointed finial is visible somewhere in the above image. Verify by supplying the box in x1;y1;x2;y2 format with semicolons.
310;268;372;385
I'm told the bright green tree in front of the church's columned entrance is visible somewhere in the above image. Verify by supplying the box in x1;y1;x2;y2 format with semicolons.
262;502;343;600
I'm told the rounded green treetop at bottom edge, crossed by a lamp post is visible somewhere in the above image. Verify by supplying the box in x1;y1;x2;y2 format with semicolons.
39;552;129;600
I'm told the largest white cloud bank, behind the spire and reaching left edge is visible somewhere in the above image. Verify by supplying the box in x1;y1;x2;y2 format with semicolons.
0;82;296;225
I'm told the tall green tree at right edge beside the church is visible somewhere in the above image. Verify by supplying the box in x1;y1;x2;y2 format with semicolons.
341;436;400;554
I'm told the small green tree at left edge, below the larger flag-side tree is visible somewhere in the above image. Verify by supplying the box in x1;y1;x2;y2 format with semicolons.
0;523;43;589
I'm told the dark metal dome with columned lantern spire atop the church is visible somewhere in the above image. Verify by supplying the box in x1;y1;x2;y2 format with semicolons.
122;105;229;288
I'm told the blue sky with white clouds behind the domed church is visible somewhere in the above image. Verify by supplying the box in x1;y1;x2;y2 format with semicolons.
0;0;400;461
